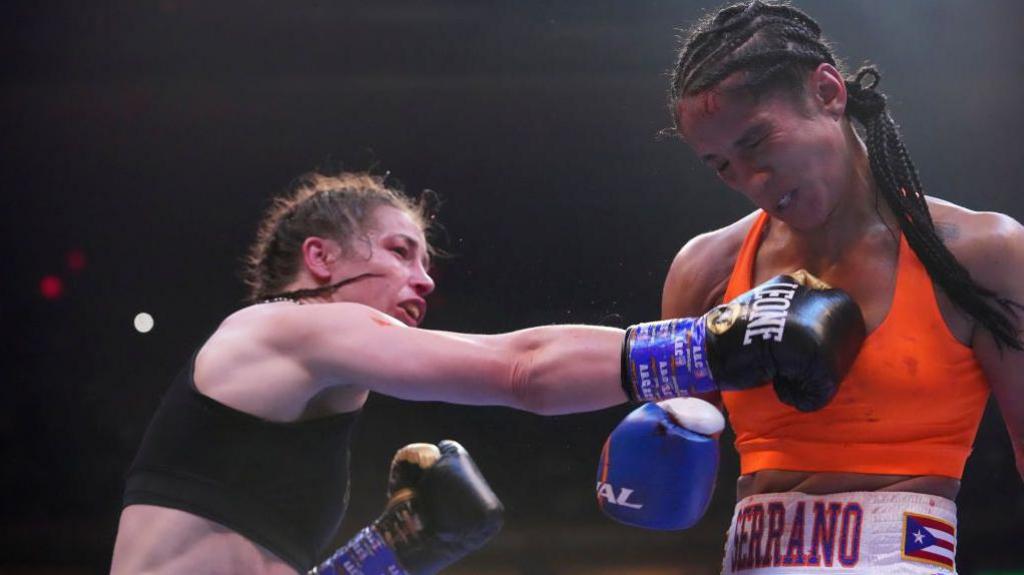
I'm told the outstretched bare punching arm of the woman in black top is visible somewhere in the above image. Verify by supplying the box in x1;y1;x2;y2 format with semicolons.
275;304;626;414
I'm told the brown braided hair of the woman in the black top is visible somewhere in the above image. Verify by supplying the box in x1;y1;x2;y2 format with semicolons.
243;172;438;303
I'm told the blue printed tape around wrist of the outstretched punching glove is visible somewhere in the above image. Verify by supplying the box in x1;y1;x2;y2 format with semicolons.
623;317;718;401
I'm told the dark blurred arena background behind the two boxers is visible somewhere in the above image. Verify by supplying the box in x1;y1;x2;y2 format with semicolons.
0;0;1024;575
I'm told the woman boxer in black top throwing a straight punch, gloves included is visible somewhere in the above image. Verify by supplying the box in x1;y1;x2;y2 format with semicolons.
112;167;862;575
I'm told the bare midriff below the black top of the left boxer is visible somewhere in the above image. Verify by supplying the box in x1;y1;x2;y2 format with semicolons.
111;505;296;575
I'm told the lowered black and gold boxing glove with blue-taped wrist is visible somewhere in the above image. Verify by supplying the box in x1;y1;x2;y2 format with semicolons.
309;440;504;575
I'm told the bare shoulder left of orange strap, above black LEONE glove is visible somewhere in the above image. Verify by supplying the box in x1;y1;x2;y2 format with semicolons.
662;212;759;317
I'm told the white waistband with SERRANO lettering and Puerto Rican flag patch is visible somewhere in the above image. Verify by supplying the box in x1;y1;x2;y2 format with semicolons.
722;491;956;575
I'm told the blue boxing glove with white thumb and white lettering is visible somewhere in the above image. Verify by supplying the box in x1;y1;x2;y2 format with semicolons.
597;397;725;530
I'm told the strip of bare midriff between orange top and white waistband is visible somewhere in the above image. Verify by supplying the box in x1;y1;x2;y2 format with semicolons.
736;470;961;500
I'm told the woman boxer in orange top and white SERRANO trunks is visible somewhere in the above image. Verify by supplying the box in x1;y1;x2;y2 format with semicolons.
663;1;1024;574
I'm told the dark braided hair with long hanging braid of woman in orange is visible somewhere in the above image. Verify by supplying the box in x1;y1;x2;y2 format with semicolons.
670;0;1024;350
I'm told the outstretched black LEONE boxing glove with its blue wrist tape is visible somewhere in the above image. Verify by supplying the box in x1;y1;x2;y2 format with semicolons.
623;270;866;411
